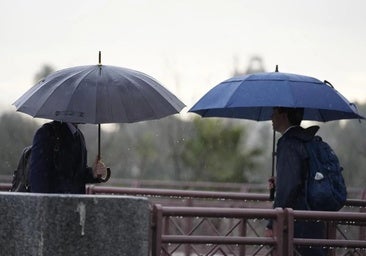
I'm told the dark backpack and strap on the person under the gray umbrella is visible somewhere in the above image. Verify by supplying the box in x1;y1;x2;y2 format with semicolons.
10;122;60;192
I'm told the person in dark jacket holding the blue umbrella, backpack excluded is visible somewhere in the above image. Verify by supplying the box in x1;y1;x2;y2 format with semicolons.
266;107;325;256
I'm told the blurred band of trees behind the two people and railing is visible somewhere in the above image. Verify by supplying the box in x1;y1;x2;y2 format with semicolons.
0;104;366;187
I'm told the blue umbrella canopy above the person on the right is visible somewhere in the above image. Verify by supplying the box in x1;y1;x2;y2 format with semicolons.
189;72;363;122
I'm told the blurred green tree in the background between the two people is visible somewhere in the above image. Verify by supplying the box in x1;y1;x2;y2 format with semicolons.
182;118;262;182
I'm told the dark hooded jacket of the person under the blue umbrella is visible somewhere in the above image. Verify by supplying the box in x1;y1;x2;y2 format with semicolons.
274;126;319;210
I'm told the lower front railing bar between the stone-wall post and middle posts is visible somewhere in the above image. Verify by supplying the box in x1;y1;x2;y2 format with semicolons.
161;235;276;245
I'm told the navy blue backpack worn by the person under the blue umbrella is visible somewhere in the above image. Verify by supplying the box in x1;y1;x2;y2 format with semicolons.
305;136;347;211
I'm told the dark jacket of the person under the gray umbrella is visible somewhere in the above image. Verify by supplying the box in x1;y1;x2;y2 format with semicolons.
29;121;98;194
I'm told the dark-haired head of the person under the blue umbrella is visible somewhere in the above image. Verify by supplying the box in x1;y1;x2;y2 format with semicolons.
272;107;304;133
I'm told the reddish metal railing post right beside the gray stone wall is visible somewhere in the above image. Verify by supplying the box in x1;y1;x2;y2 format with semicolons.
151;204;163;256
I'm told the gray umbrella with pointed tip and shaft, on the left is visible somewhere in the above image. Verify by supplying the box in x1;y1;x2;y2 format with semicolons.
13;53;185;157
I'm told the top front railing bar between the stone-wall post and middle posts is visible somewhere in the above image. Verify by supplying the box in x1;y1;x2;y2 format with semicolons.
161;206;277;218
